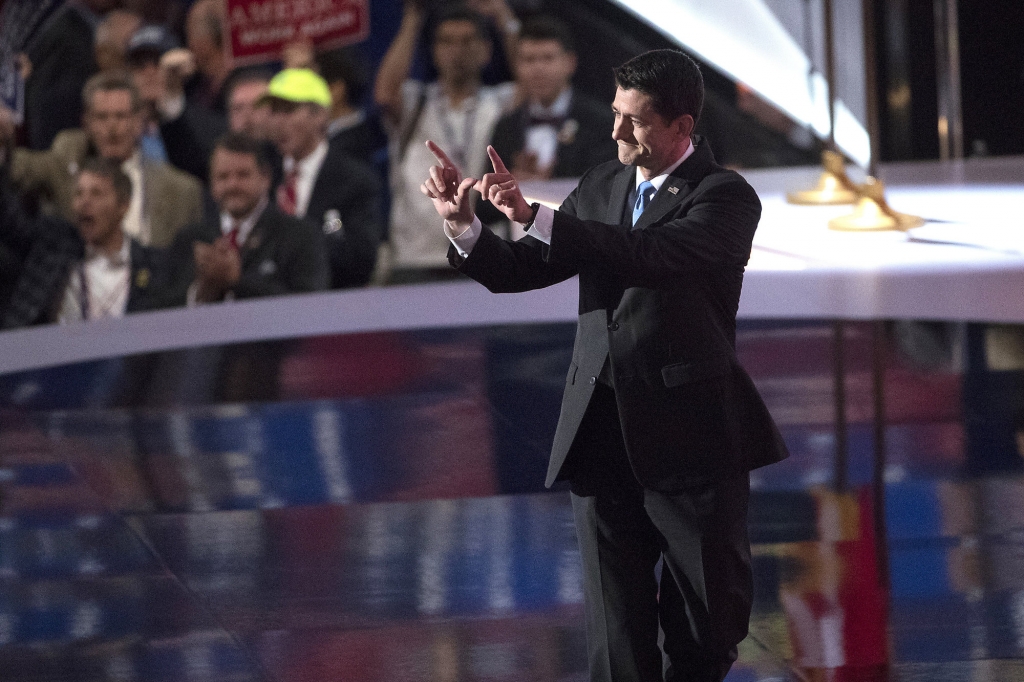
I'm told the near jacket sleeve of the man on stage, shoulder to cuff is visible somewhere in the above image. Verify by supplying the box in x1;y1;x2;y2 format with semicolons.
548;172;761;288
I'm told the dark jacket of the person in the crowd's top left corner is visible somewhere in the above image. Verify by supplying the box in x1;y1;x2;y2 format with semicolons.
25;5;96;150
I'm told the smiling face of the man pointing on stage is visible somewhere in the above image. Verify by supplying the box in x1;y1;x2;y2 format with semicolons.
611;88;693;179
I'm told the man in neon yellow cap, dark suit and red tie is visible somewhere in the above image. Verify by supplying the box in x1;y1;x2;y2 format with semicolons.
263;69;383;289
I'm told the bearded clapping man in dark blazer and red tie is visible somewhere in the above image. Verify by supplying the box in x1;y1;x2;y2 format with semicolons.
167;133;328;305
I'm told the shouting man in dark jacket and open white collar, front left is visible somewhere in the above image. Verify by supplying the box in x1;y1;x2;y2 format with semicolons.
0;159;163;329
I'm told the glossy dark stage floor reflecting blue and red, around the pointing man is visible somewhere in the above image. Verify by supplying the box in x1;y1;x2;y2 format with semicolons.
0;315;1024;682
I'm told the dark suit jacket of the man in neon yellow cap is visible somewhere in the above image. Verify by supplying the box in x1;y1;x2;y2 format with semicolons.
284;140;383;289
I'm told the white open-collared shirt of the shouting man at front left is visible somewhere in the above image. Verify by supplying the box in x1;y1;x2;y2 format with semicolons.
57;237;131;325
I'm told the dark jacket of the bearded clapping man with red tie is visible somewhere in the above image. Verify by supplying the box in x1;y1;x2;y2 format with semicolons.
165;197;328;305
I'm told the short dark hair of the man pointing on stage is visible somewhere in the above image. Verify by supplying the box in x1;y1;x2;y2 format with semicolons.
615;50;703;124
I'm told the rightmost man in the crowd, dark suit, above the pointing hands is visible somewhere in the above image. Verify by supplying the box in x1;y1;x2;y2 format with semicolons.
490;16;615;181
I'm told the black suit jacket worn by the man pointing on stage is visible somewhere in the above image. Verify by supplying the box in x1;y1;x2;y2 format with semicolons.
449;138;786;492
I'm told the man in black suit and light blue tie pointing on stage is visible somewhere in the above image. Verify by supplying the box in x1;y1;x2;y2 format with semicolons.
422;50;786;682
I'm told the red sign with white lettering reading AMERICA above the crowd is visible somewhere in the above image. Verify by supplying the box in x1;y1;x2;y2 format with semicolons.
224;0;370;66
